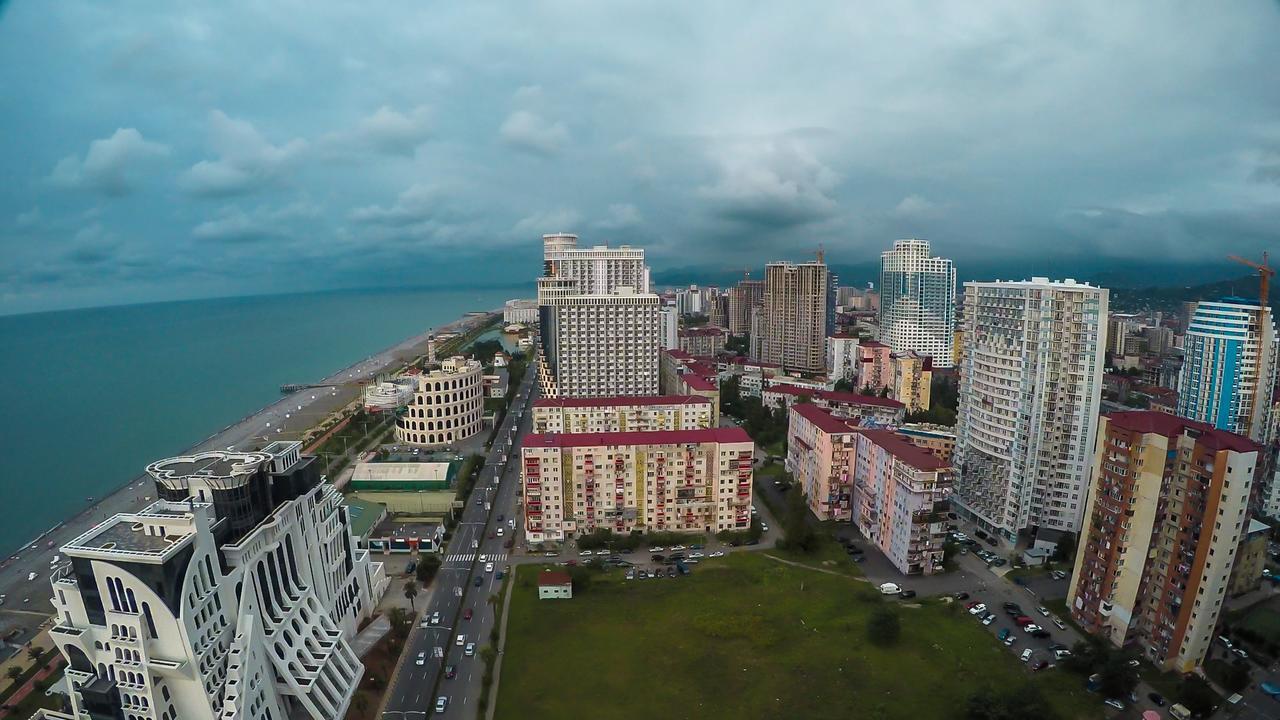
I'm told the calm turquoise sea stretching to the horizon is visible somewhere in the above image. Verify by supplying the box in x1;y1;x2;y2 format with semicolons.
0;283;531;556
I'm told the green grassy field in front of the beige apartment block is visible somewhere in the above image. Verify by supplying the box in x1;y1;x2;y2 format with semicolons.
497;552;1101;720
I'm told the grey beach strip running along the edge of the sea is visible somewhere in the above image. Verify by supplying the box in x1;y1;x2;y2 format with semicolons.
0;307;502;632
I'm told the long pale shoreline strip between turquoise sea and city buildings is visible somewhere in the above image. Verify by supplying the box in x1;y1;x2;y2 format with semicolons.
0;310;500;661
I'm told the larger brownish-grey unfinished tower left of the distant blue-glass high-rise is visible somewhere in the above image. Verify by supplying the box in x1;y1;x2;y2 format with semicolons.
759;261;833;373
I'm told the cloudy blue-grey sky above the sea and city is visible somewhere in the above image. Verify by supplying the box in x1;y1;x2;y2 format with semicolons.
0;0;1280;314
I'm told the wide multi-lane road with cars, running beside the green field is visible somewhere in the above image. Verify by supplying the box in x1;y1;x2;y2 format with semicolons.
383;373;538;719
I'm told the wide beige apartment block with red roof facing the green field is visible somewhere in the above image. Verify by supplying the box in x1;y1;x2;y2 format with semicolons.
521;428;755;543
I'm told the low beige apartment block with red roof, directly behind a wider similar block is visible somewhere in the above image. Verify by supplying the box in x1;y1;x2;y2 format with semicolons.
534;395;714;433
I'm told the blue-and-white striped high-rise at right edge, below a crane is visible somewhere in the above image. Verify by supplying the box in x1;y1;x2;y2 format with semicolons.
1178;297;1276;441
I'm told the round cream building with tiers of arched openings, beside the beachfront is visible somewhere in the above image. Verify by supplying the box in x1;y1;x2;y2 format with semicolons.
396;356;484;447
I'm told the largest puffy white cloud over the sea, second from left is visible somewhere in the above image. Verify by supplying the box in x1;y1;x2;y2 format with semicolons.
179;110;307;196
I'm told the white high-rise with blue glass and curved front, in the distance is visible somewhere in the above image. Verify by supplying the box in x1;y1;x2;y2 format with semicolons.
879;240;956;368
